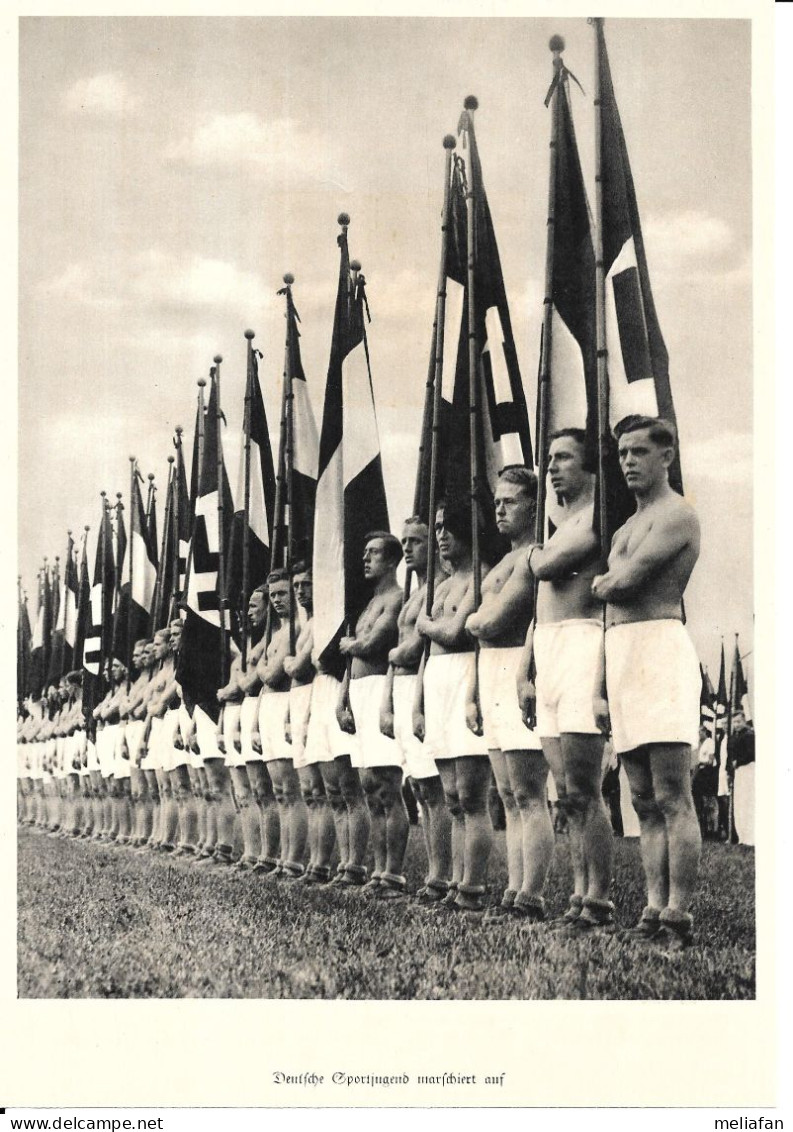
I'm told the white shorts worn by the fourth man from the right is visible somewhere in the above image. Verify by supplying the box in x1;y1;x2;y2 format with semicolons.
424;652;488;760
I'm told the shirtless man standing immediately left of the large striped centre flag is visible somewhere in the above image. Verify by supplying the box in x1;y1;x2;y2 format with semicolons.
284;563;336;884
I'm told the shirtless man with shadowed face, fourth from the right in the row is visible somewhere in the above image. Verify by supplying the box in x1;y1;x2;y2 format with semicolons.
416;500;492;915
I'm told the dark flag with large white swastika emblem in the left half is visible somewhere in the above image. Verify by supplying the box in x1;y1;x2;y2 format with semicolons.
176;370;233;720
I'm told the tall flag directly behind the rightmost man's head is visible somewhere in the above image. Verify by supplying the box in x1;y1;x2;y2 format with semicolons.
594;19;683;532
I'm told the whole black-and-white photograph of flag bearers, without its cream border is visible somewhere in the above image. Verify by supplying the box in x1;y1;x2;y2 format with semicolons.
13;6;765;1036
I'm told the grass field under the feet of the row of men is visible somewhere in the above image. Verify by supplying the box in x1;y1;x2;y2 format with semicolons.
18;827;755;998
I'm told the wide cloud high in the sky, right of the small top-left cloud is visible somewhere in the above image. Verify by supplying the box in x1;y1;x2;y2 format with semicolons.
165;111;339;184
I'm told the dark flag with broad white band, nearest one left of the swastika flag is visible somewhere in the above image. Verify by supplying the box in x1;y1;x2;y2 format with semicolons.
115;468;157;669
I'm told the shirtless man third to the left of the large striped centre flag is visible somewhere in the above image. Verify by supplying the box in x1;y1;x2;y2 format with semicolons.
227;583;281;874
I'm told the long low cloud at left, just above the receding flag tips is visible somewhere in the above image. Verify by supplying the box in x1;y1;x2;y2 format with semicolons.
41;248;271;310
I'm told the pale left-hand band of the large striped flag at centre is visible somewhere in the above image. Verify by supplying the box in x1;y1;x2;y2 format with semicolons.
313;446;344;654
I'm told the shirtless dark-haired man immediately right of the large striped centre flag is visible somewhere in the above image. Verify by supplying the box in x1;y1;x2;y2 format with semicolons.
339;531;410;897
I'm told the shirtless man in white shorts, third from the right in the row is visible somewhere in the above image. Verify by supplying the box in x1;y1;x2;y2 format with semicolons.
466;466;553;921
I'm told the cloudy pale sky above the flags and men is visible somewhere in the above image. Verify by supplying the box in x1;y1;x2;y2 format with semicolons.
18;17;753;680
